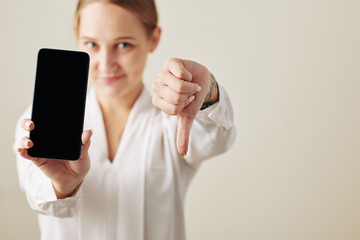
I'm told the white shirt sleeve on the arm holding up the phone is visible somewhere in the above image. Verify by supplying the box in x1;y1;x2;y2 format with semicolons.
13;107;81;218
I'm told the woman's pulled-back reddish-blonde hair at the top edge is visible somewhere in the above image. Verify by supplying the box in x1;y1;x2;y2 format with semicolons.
74;0;158;36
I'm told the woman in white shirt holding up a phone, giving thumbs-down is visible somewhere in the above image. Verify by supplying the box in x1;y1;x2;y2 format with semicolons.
15;0;235;240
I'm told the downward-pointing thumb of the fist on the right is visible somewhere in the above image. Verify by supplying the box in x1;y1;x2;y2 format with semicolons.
176;116;194;158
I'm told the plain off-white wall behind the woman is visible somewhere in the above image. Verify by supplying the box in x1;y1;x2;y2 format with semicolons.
0;0;360;240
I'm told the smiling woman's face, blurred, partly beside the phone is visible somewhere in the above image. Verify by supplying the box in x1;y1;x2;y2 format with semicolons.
78;2;160;97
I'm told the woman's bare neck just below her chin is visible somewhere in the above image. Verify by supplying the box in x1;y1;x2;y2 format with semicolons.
95;83;144;115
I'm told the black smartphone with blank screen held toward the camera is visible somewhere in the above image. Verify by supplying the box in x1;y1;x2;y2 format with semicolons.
28;48;90;160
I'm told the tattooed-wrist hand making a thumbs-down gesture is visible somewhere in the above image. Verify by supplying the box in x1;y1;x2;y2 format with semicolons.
152;58;219;157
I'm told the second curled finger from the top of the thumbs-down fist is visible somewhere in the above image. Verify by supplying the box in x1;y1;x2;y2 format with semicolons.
158;71;201;94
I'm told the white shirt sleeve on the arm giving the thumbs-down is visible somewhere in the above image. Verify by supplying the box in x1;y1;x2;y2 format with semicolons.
185;85;236;168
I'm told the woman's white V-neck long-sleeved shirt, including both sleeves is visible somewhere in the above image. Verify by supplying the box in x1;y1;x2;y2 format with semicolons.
14;87;236;240
